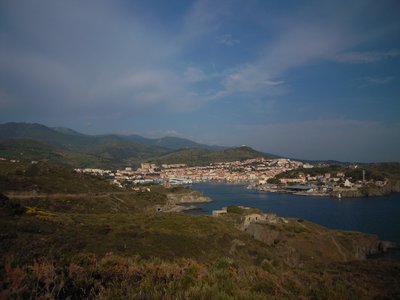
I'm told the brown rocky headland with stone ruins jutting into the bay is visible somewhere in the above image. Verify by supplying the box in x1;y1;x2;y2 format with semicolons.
213;206;399;266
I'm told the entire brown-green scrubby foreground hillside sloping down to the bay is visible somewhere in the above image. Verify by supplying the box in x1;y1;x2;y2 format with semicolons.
0;162;400;299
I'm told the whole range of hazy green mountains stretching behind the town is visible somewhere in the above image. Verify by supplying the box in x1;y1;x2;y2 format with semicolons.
0;123;276;167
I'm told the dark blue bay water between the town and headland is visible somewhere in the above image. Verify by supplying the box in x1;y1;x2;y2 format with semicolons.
192;183;400;245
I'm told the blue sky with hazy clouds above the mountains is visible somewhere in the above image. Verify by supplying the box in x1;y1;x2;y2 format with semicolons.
0;0;400;162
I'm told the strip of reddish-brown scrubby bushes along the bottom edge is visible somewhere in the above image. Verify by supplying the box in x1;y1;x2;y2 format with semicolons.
0;253;398;299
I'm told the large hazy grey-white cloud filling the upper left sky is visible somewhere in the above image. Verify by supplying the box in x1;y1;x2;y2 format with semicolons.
0;0;194;116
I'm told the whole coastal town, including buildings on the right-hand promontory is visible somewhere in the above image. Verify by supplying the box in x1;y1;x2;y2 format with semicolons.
75;158;388;198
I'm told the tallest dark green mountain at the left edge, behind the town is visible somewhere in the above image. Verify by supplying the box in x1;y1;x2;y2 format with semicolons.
0;123;167;167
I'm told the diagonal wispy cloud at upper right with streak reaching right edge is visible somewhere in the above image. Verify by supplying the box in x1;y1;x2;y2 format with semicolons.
206;1;400;99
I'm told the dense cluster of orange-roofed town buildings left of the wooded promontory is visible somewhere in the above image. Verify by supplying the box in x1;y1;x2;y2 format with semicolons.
75;158;304;187
